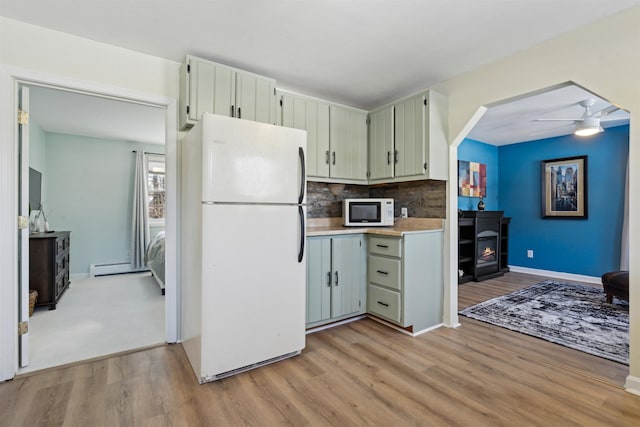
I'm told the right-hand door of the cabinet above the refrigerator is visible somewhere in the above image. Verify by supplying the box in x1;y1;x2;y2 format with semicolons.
235;73;276;124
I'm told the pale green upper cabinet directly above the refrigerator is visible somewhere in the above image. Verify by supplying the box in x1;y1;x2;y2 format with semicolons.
180;55;276;129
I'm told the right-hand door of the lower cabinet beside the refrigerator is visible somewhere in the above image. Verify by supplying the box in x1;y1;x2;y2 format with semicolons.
331;236;366;317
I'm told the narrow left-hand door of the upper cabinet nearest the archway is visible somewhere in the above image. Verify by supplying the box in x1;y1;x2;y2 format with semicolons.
369;106;394;179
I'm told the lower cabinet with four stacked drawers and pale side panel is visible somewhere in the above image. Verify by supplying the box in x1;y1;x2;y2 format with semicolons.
367;231;443;333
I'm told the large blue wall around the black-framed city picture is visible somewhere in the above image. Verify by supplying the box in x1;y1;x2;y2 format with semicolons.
498;126;629;277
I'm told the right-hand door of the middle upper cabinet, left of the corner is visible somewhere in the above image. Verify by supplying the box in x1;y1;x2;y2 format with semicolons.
329;105;367;182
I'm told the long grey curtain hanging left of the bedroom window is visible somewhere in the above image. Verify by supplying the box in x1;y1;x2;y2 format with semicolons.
131;150;149;270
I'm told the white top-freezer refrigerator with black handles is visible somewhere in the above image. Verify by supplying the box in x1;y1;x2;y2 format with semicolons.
180;114;306;383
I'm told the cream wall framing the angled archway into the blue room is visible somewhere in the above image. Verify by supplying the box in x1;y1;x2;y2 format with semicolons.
435;7;640;392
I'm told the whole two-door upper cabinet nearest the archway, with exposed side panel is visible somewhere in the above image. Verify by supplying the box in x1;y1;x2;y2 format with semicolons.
369;90;448;183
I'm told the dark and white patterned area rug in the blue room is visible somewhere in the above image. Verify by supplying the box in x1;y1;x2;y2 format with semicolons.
460;280;629;365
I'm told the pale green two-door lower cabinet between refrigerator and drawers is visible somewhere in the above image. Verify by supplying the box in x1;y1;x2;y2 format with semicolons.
306;234;367;327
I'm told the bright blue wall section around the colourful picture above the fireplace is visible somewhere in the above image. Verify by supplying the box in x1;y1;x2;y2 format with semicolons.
456;139;499;211
